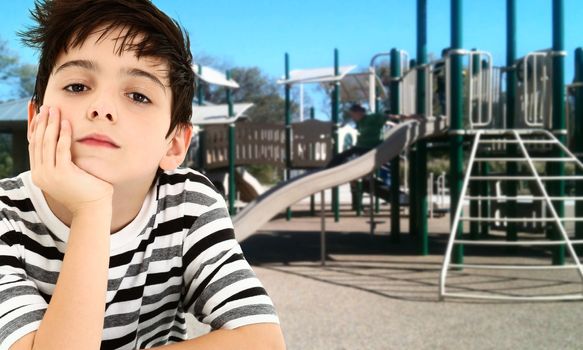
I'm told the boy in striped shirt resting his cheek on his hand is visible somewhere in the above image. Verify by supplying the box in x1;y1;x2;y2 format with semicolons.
0;0;285;350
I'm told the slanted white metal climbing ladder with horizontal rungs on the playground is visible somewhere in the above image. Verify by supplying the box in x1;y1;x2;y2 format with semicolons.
439;130;583;301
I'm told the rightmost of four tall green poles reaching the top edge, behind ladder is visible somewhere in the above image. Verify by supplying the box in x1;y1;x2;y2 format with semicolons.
550;0;566;265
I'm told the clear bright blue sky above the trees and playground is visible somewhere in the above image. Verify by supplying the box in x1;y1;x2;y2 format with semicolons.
0;0;583;116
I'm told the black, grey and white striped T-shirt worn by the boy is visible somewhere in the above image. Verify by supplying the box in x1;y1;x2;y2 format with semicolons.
0;169;279;349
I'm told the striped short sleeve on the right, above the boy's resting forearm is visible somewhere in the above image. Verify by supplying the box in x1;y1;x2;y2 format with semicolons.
183;193;279;329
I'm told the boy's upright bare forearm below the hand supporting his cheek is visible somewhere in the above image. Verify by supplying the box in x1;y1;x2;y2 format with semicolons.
33;205;111;350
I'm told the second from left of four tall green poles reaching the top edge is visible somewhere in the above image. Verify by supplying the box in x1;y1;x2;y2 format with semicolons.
449;0;464;264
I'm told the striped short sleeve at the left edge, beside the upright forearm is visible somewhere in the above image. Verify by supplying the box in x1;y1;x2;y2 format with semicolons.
0;224;47;349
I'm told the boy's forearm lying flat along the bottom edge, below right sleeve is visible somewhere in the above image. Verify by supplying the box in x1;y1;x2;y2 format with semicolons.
156;323;285;350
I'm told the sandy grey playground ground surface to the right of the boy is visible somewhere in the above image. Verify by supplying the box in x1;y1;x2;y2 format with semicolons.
191;201;583;349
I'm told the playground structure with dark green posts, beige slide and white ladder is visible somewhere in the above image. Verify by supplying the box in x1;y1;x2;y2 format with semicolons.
188;0;583;300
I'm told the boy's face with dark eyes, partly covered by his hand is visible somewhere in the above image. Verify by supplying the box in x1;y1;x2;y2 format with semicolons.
37;31;190;185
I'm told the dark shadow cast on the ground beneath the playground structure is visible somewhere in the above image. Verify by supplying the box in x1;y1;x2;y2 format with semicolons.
241;231;581;303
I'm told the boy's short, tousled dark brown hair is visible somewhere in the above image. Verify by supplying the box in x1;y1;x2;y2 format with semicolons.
18;0;195;135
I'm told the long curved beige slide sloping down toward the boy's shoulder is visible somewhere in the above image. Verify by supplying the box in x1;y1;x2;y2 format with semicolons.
233;117;445;241
